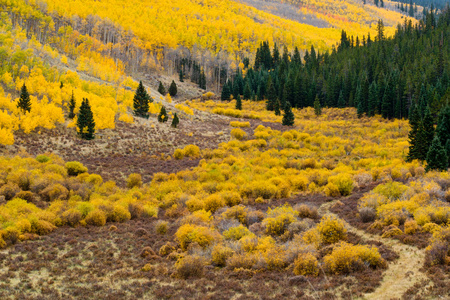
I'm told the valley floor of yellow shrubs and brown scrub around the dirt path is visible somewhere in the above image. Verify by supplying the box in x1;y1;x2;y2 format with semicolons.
0;101;450;298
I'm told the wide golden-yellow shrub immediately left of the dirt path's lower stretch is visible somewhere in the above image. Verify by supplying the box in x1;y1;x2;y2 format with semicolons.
324;242;386;274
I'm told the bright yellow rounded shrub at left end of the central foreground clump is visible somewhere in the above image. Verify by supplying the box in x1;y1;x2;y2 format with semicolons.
175;224;218;250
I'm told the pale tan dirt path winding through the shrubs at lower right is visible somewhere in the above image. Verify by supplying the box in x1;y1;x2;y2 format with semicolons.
319;200;427;300
